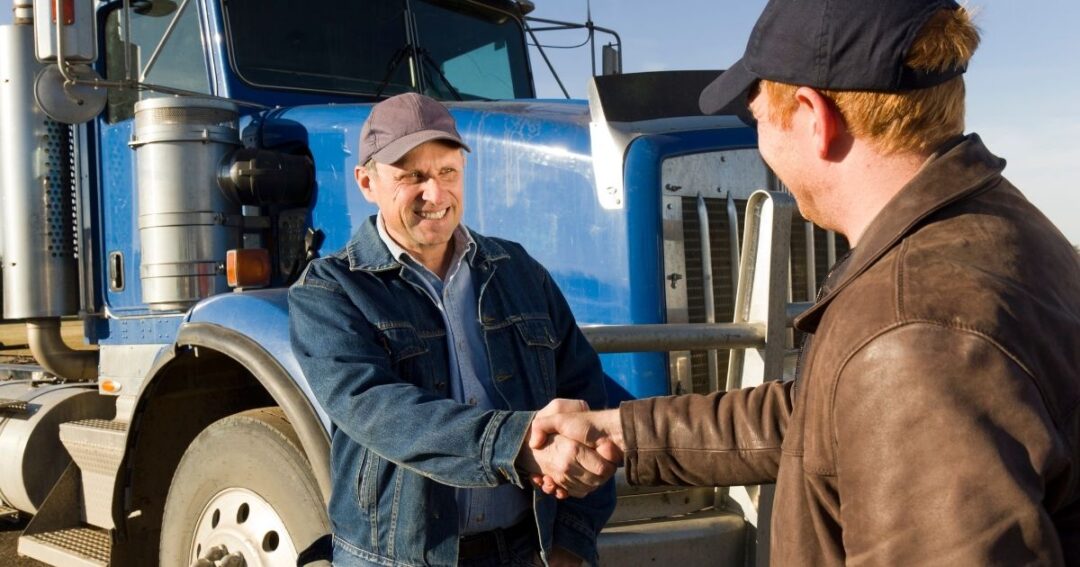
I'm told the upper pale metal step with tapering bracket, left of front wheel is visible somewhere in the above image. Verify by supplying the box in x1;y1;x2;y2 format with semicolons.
60;419;127;529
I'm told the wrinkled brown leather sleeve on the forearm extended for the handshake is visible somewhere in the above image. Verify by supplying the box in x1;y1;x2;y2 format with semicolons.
620;381;792;486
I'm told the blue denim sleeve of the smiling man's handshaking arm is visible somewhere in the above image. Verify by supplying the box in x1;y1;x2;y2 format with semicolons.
289;286;531;487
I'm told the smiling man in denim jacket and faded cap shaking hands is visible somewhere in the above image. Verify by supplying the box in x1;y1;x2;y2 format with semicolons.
289;93;615;566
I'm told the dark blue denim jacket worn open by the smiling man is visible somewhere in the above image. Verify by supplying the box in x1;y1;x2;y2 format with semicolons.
288;217;615;566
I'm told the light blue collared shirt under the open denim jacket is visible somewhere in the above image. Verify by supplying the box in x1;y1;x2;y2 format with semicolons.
376;213;532;536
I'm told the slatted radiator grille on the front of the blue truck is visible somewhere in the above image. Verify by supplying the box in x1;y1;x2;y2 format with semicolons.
661;148;848;393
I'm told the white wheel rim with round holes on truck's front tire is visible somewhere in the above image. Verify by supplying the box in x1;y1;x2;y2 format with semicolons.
190;488;297;567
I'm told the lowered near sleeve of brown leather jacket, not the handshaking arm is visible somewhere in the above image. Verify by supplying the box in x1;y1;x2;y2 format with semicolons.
833;323;1070;565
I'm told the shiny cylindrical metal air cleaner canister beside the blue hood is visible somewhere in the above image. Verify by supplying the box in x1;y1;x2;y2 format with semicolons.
131;97;241;311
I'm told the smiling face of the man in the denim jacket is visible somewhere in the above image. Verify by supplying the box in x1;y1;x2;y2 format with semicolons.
355;141;465;274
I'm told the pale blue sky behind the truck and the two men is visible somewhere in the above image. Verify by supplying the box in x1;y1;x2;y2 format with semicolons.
0;0;1080;244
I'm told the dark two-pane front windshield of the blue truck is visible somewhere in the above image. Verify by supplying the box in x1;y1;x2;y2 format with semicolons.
222;0;534;100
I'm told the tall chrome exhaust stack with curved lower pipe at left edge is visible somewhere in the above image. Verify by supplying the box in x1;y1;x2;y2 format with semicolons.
0;1;97;379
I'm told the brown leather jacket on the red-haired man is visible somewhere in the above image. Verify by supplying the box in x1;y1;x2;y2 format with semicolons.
621;135;1080;566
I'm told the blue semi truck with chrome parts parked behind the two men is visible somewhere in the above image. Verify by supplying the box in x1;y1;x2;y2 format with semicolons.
0;0;843;566
